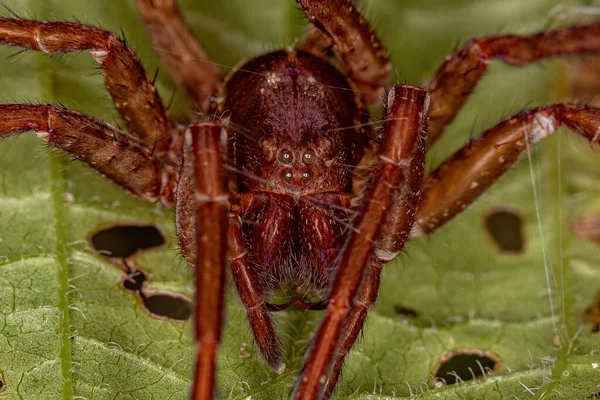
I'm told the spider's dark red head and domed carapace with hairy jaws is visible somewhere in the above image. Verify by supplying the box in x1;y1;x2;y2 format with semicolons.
219;49;368;291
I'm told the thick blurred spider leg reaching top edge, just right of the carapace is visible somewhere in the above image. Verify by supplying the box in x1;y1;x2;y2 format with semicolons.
296;0;392;104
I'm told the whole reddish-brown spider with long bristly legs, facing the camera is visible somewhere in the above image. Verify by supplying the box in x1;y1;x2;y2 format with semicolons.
0;0;600;399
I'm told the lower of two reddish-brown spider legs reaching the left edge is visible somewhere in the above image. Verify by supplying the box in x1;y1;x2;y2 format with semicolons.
0;104;175;204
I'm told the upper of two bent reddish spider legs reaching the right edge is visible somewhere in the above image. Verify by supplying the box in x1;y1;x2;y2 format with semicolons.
427;24;600;145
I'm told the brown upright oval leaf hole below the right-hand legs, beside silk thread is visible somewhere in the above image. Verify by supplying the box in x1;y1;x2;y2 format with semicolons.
485;208;525;253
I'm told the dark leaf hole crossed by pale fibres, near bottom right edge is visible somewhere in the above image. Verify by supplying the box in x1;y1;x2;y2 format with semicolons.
433;349;500;385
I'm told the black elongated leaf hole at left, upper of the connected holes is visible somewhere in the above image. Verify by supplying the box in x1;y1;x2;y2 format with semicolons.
91;225;165;258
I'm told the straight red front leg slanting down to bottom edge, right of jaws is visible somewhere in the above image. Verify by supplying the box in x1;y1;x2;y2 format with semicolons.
293;85;429;399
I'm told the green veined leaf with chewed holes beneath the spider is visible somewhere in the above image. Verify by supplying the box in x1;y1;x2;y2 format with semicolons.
0;0;600;400
